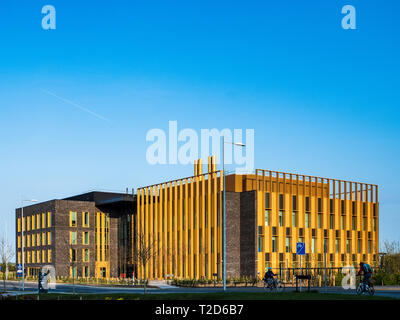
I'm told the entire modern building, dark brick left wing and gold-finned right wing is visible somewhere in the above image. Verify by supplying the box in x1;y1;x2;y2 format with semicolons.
16;157;379;279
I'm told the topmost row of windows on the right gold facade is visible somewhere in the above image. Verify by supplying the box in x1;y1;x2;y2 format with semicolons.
265;192;376;217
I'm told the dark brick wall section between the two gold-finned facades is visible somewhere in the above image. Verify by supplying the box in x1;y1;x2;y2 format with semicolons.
226;191;257;277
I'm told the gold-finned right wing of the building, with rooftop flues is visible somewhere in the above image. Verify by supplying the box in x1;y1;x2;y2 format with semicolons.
134;158;379;279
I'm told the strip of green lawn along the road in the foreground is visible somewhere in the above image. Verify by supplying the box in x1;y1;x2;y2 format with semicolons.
14;292;391;300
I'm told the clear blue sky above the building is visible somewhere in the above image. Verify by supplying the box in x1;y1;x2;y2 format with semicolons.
0;0;400;248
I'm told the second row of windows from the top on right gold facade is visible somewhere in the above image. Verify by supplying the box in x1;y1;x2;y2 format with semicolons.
265;209;377;231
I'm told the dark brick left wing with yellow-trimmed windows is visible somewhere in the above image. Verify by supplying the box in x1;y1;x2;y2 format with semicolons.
16;192;136;278
